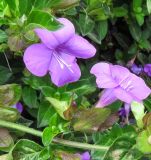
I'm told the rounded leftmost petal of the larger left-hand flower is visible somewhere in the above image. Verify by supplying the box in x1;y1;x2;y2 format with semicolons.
23;44;51;77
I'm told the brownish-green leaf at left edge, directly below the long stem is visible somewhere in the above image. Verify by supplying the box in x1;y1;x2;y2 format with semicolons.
0;128;14;152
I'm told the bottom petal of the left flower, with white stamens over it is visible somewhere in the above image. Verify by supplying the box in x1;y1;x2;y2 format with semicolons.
49;53;81;87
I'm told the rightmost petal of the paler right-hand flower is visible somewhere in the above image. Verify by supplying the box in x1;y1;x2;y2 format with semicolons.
129;74;151;101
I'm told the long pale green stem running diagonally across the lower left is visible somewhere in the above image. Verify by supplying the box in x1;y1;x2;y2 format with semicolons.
0;120;109;150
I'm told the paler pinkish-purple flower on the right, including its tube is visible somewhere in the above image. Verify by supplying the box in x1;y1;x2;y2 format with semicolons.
91;62;151;107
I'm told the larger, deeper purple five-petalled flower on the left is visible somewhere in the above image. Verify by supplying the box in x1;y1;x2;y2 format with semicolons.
24;18;96;86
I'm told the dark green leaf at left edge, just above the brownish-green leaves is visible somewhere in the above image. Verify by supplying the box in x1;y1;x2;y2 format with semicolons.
0;66;12;85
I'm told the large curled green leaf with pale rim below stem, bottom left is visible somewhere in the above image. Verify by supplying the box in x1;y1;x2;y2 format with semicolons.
9;139;44;160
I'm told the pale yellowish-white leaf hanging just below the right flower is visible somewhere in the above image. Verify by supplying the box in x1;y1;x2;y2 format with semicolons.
131;102;145;128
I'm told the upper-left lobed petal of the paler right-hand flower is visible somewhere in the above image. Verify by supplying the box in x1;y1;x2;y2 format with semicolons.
90;63;118;88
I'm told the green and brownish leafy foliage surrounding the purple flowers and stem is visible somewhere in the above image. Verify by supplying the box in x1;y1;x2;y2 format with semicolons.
0;0;151;160
